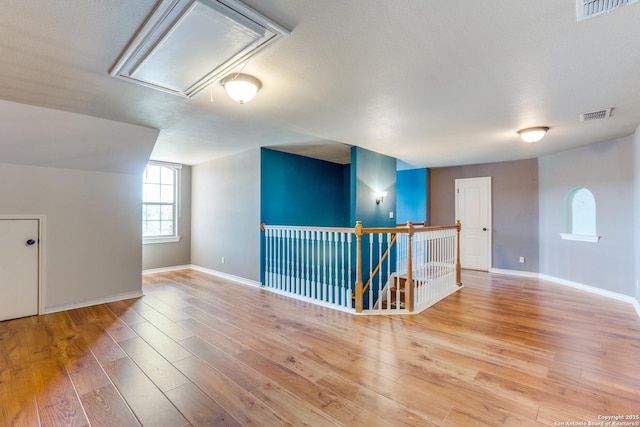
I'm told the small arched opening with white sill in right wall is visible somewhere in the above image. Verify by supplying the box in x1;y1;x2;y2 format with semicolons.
560;187;600;242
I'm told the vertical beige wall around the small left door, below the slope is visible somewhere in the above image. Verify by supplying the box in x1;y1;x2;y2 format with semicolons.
0;164;142;310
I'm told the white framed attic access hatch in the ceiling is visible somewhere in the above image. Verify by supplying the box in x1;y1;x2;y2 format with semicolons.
109;0;289;98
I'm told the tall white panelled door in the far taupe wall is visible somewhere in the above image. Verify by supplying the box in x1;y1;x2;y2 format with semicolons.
456;177;491;271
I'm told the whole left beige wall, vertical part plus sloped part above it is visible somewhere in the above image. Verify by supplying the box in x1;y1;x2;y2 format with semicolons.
0;100;159;311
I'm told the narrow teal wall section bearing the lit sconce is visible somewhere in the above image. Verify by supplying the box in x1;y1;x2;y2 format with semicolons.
350;147;396;227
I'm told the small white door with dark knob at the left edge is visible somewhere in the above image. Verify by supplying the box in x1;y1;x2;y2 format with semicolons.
0;219;39;320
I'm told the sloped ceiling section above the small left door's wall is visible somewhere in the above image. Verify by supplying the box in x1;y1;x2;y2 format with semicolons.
0;100;159;175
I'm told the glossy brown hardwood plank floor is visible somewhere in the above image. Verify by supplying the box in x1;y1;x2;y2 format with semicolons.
0;270;640;427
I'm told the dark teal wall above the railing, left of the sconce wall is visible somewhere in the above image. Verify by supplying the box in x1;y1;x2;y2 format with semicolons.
260;148;349;227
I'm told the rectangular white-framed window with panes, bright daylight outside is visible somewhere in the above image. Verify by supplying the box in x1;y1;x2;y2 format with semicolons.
142;162;181;243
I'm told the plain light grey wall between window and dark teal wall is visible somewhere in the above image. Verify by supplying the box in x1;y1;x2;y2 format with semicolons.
191;149;261;281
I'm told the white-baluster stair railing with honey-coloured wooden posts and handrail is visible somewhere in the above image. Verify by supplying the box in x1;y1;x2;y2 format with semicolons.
261;221;461;313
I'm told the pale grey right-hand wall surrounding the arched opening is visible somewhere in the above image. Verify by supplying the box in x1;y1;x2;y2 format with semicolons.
538;136;637;296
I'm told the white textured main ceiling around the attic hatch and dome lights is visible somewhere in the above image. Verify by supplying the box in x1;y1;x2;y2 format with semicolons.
0;0;640;167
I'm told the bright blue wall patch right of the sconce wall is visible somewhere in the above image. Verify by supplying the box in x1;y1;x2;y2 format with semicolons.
397;169;427;224
